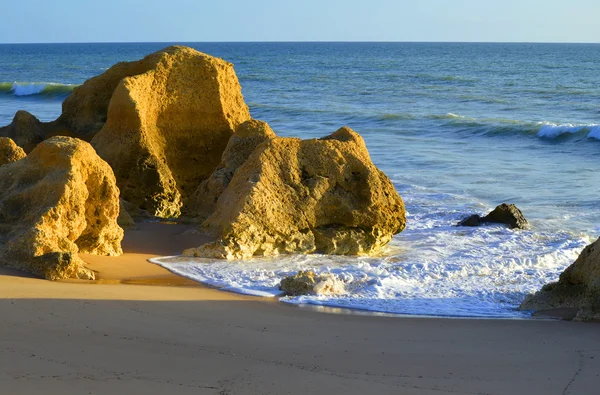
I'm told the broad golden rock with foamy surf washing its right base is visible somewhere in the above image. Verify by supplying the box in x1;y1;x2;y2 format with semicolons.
184;127;406;259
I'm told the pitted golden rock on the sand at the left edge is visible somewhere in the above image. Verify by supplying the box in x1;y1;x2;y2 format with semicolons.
0;137;123;280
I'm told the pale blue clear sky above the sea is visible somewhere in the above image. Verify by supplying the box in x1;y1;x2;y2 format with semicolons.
0;0;600;43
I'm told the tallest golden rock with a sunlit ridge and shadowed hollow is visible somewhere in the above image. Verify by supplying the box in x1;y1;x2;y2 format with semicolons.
89;47;250;217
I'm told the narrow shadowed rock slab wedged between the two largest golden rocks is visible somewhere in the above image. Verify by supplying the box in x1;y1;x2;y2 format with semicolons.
186;119;277;220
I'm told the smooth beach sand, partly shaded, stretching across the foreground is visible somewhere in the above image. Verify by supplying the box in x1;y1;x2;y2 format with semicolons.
0;224;600;395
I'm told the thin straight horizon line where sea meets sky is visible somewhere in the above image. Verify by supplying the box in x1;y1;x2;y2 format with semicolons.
0;40;600;45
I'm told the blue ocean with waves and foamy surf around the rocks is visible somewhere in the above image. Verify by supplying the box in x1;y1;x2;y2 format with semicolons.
0;43;600;318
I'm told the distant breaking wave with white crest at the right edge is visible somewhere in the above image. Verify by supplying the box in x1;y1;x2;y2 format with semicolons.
429;113;600;140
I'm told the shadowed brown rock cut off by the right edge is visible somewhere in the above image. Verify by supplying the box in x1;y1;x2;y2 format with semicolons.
520;238;600;321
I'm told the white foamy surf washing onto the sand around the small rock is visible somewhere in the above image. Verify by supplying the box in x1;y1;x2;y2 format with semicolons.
155;201;590;318
